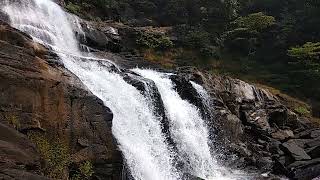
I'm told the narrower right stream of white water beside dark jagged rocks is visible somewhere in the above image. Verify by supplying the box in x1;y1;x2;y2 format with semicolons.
133;69;232;179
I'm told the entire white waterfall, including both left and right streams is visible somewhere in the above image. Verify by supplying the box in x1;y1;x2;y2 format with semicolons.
0;0;244;180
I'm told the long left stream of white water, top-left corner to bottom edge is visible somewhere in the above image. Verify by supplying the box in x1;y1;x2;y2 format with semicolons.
2;0;178;180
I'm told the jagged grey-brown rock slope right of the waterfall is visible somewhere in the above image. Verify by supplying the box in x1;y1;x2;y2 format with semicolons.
178;68;320;179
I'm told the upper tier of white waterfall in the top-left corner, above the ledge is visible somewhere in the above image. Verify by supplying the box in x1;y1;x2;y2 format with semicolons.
2;0;80;54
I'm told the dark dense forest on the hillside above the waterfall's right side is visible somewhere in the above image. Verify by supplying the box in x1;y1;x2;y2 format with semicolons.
66;0;320;116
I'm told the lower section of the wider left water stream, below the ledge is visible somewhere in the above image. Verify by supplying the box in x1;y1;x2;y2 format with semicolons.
60;55;178;180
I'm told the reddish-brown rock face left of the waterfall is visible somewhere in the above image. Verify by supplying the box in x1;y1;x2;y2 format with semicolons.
0;22;122;179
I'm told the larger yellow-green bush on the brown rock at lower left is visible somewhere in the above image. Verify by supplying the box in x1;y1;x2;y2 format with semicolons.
27;132;70;179
